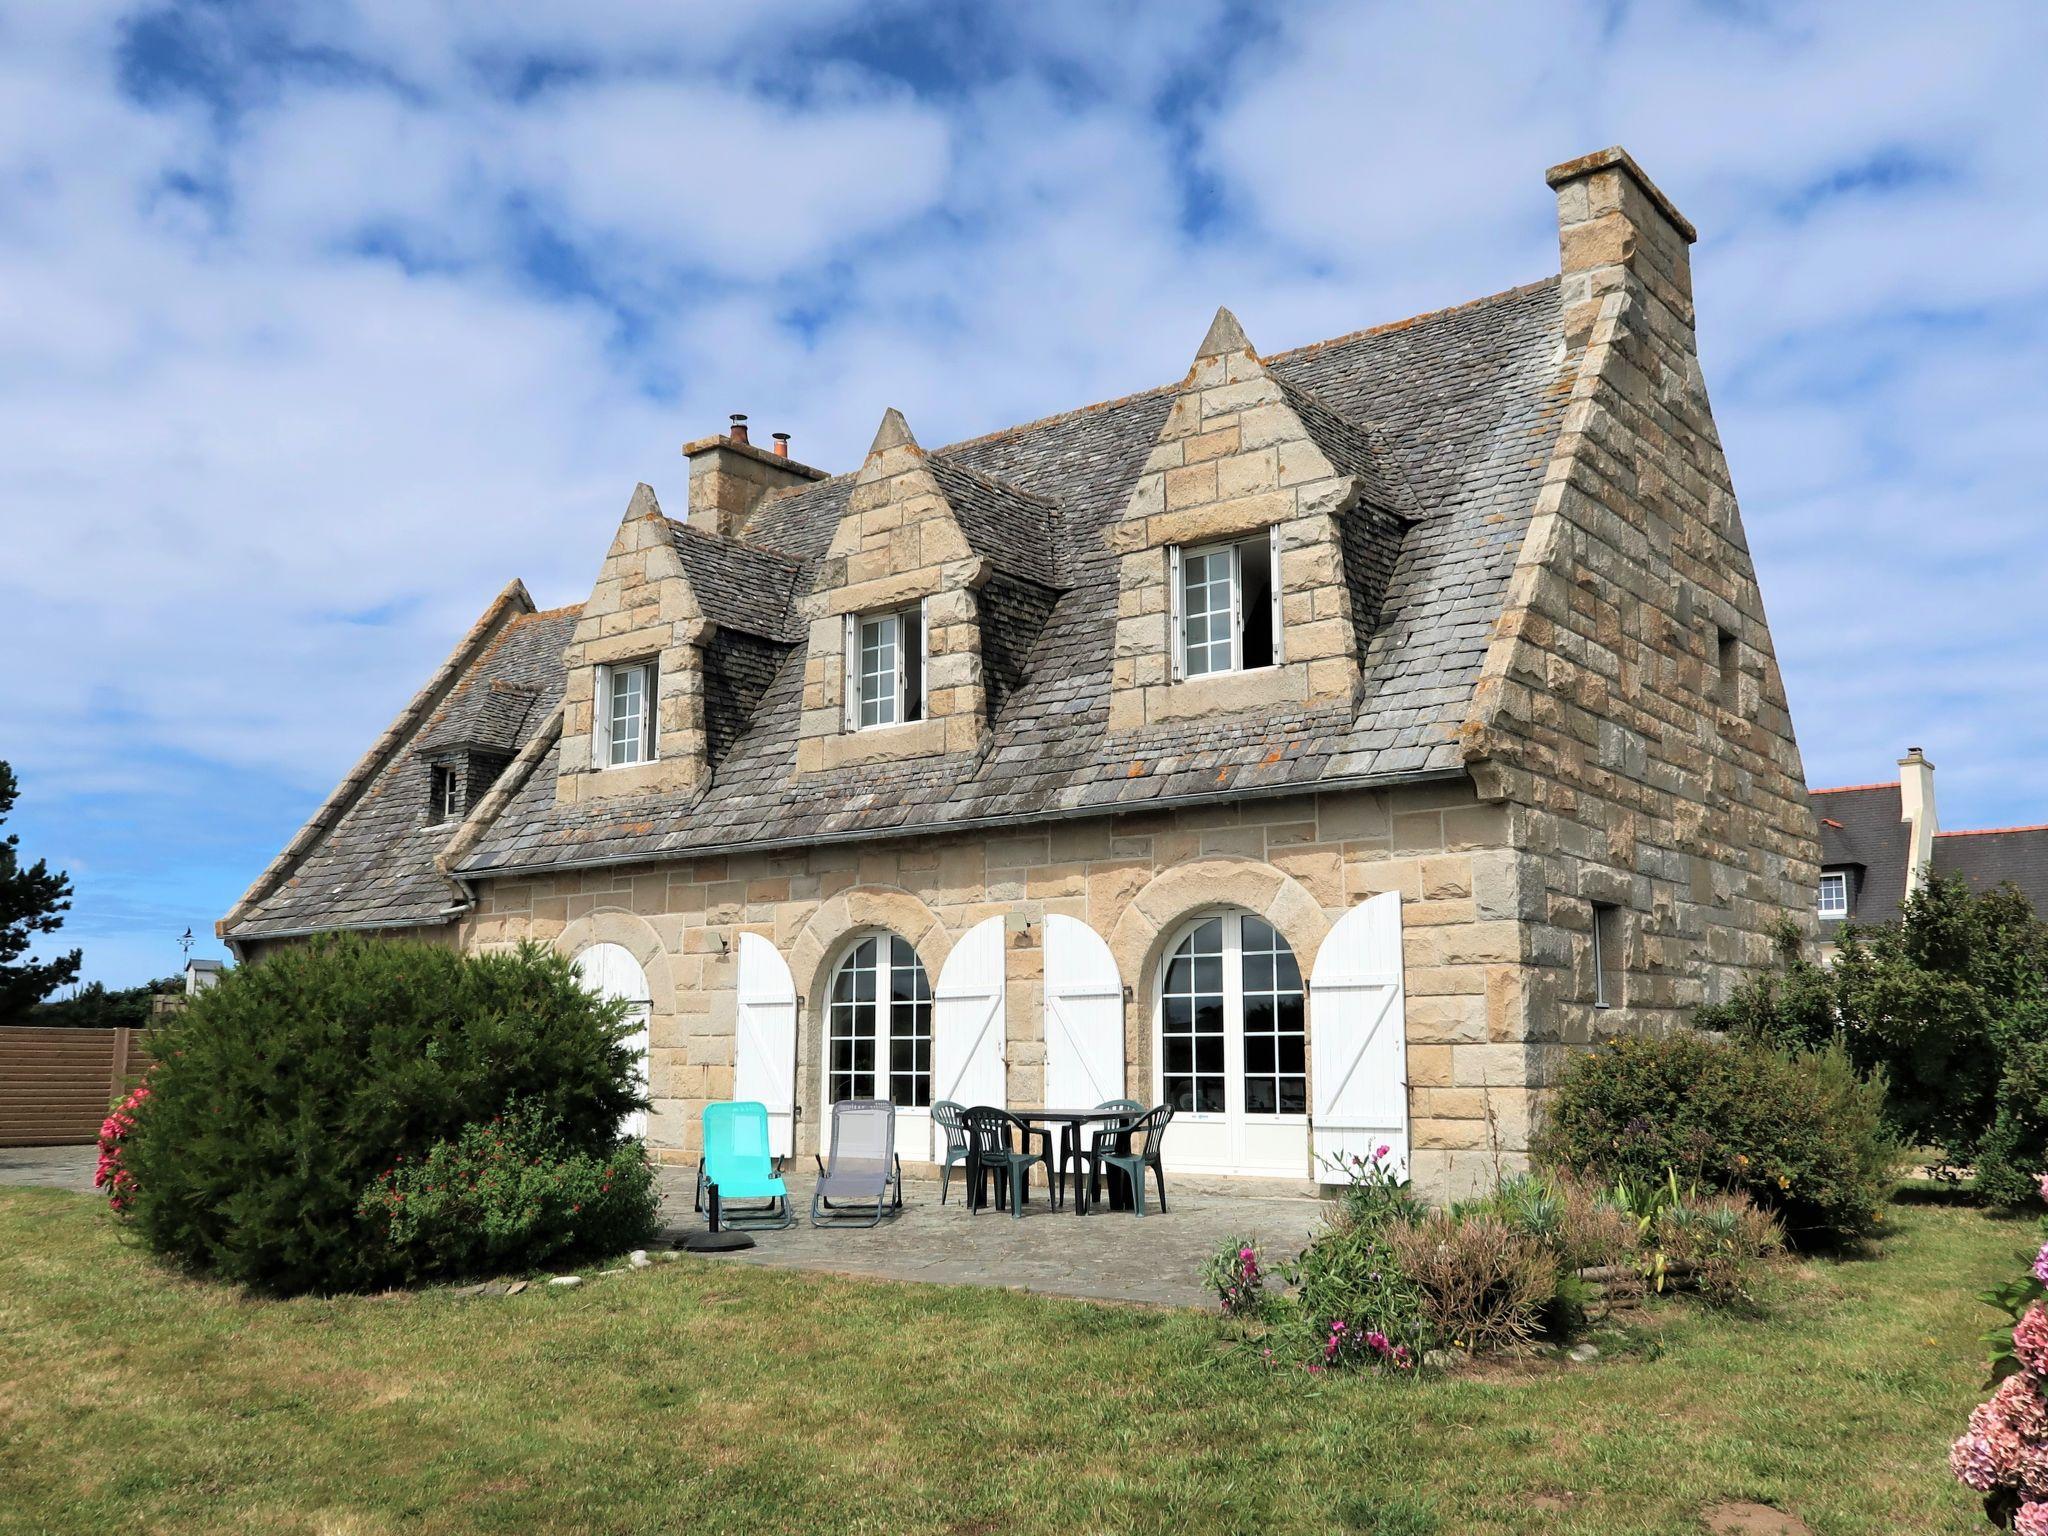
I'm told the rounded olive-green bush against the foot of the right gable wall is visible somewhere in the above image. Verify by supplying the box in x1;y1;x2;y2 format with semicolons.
1536;1030;1898;1243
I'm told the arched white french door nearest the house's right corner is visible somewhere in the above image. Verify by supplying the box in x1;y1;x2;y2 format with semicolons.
1153;911;1309;1178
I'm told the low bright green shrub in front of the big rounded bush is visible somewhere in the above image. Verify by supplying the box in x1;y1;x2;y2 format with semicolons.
356;1106;659;1280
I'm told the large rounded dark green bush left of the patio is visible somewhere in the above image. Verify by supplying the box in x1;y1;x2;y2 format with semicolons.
123;936;643;1292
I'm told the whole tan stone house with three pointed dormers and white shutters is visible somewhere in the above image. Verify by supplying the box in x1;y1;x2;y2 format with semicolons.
221;150;1819;1196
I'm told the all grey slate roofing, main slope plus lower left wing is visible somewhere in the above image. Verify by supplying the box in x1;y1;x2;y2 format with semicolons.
229;279;1575;938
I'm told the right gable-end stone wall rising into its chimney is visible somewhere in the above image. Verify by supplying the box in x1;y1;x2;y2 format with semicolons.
1464;152;1819;1145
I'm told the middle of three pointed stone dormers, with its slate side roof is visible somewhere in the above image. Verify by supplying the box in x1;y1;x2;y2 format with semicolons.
797;410;1057;772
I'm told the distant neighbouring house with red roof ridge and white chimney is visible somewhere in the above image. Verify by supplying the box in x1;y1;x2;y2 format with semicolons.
1812;748;2048;956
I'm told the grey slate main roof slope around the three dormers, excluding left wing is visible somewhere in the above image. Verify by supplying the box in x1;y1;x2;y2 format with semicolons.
463;281;1571;874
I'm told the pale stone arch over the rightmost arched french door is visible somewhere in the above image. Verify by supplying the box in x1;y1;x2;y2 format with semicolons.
1108;854;1329;1122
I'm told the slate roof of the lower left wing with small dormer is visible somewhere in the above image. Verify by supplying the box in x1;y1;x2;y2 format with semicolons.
229;608;578;938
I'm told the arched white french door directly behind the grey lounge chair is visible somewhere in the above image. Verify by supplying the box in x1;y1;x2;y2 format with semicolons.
821;932;932;1161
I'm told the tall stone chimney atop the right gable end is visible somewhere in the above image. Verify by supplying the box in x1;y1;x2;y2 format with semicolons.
1544;145;1700;346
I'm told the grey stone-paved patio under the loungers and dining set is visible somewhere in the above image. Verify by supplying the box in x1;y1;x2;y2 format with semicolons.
662;1167;1325;1307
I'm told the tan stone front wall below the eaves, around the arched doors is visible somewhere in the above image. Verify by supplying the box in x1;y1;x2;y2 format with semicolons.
461;780;1526;1192
